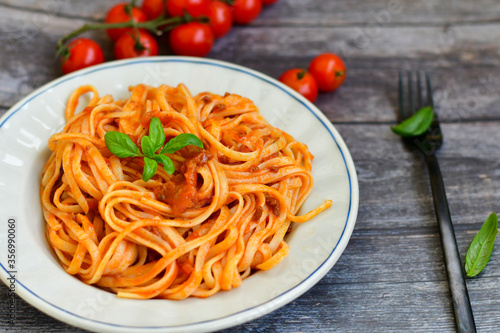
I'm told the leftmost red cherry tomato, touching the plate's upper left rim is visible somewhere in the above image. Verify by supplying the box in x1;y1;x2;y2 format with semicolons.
61;38;104;74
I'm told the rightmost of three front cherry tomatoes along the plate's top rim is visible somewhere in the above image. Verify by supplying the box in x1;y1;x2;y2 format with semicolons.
170;21;214;57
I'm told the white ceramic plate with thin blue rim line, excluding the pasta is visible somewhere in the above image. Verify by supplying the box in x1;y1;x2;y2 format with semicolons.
0;57;359;332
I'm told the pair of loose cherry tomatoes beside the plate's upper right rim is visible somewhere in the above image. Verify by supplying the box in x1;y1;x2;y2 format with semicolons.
279;53;346;102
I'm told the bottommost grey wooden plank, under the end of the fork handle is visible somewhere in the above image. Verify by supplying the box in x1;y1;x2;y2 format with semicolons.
228;279;500;332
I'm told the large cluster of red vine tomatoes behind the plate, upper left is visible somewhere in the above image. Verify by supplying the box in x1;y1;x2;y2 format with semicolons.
62;0;278;74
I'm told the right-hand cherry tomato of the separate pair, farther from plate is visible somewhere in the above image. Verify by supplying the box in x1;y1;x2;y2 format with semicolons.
308;53;346;92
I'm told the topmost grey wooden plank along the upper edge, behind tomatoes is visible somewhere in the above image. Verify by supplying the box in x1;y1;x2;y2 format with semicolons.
0;0;500;27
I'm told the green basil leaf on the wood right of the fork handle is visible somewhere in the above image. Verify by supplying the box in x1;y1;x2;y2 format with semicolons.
465;213;498;276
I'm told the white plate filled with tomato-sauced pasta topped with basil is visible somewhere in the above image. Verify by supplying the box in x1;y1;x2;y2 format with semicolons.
0;57;359;332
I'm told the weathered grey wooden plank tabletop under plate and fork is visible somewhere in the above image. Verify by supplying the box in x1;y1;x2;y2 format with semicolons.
0;0;500;332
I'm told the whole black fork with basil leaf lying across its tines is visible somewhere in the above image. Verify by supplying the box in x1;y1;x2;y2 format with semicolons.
399;71;476;332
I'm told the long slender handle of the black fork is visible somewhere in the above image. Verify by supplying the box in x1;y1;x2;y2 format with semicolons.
426;154;476;333
